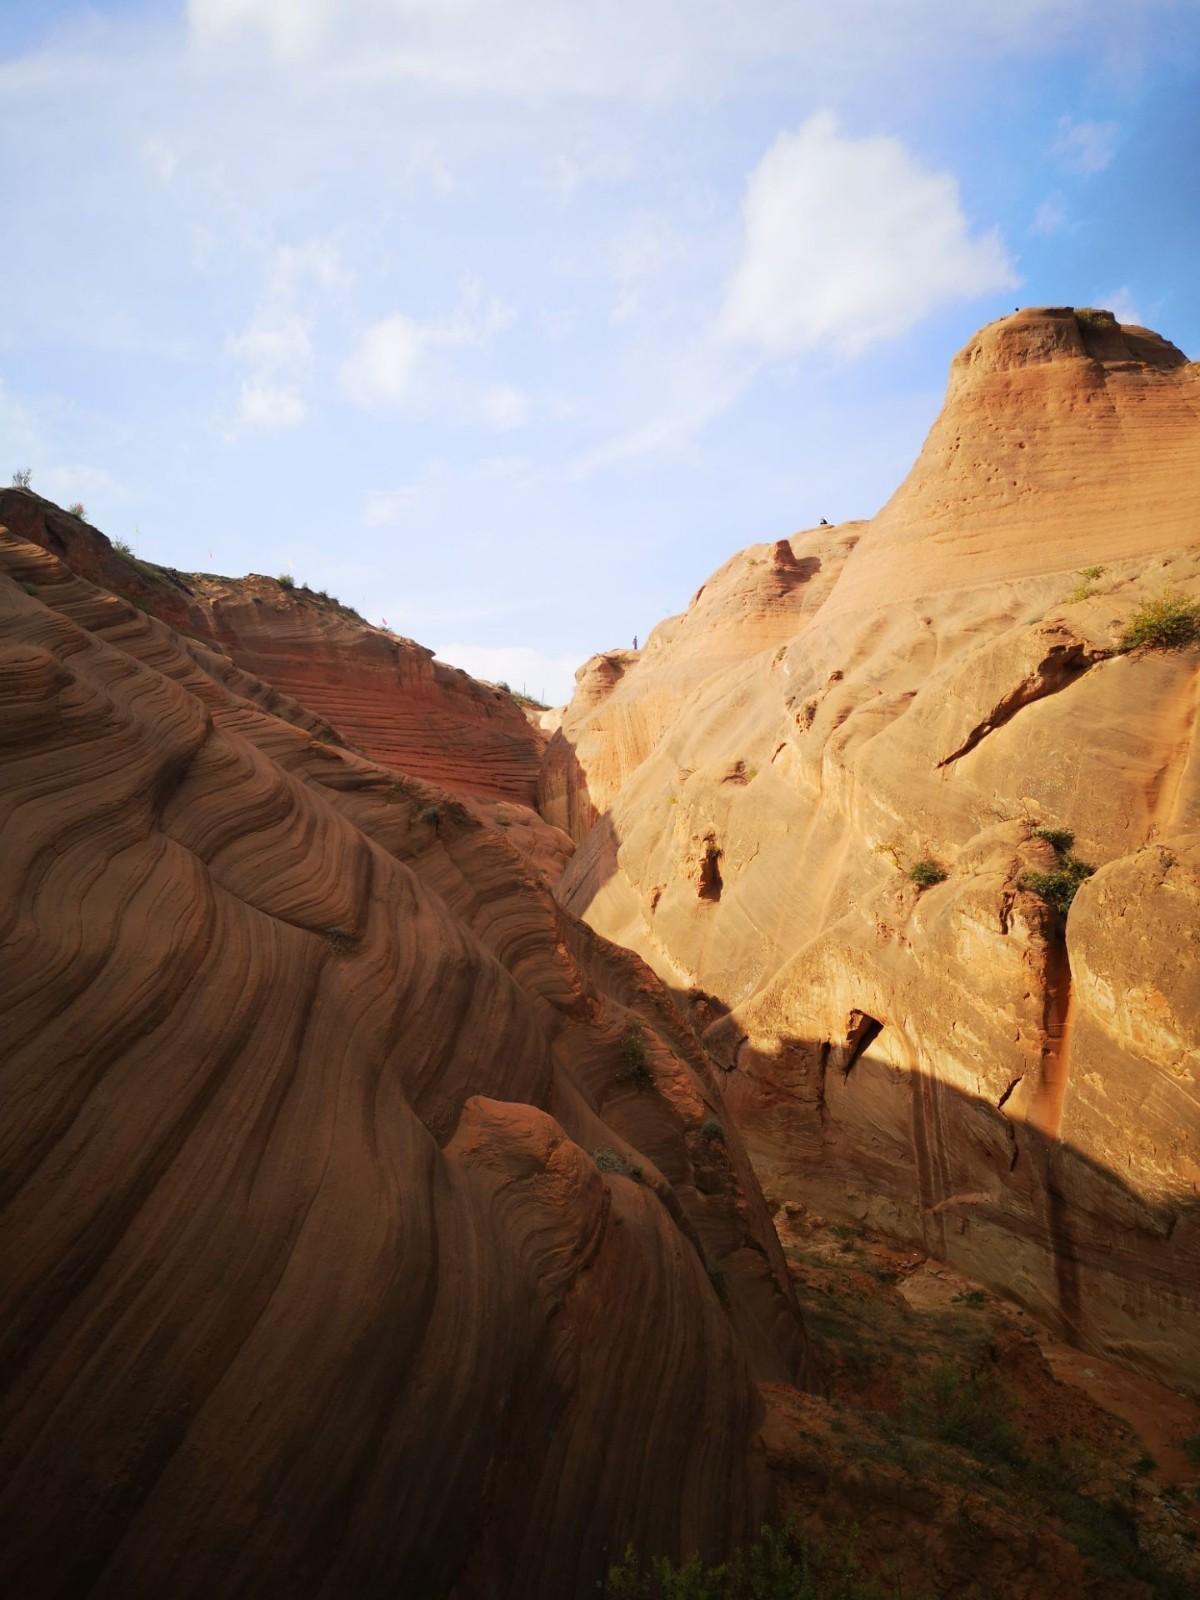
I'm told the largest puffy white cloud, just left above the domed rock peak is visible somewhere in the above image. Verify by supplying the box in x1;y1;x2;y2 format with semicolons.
722;112;1019;357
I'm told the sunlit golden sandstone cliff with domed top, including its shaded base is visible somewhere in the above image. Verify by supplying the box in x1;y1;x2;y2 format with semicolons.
553;309;1200;1386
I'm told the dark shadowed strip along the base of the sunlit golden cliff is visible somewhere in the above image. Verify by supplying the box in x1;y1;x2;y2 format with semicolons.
675;992;1200;1394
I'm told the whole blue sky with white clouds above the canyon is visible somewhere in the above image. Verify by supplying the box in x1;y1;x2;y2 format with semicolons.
0;0;1200;699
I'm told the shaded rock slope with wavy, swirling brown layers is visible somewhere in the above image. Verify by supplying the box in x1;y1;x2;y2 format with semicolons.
0;518;805;1600
